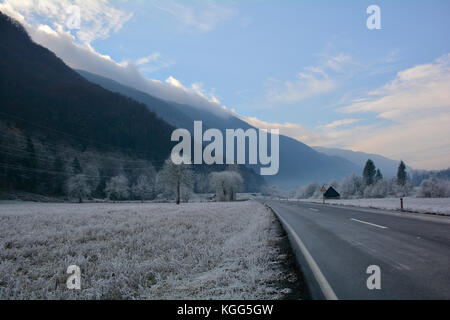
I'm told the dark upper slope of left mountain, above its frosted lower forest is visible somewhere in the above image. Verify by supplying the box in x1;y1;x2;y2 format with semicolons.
0;13;173;161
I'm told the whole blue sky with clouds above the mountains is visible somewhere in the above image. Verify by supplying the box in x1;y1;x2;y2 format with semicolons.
0;0;450;169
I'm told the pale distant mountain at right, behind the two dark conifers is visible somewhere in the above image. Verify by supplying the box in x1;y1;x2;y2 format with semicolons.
313;147;400;178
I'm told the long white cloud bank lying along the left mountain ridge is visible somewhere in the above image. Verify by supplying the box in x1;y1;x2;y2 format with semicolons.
0;1;229;116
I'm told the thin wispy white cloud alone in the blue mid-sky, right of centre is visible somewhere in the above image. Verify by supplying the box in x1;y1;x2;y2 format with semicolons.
265;53;352;104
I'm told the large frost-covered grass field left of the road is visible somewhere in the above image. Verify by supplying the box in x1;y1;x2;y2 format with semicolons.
0;201;288;299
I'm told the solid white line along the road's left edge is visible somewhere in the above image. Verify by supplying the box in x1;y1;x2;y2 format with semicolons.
265;204;339;300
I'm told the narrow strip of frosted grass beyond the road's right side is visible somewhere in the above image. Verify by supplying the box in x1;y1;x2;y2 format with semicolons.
300;197;450;215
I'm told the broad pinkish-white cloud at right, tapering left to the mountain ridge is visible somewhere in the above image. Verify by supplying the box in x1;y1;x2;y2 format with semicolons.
241;54;450;169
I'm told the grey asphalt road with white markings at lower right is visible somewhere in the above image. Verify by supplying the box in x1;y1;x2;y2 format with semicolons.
266;201;450;299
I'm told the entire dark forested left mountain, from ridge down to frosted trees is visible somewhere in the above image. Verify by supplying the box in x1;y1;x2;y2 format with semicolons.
0;12;265;197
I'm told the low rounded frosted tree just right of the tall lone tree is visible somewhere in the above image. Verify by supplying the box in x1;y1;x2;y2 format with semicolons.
209;171;244;201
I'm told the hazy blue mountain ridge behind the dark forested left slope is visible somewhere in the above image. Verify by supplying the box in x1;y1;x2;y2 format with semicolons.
78;71;361;188
